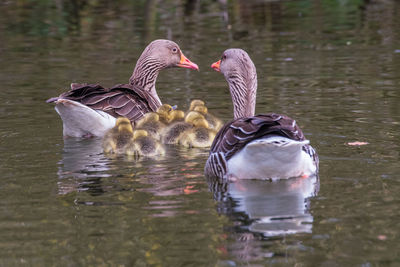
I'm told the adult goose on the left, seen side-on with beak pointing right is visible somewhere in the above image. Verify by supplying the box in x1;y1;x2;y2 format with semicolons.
47;40;199;137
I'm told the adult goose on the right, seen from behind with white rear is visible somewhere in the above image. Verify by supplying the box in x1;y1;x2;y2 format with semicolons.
205;49;318;179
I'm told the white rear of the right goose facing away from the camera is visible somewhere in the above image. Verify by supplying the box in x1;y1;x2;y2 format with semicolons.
227;136;316;179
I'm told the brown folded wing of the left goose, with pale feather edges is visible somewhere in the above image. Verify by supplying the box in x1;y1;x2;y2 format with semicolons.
47;84;159;121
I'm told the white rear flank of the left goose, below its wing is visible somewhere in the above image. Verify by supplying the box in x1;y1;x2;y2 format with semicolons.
55;99;116;137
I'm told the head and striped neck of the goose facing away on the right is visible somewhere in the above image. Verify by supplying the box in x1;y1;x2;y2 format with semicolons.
211;48;257;119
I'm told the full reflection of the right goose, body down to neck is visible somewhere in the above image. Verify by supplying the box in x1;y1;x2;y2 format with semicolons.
209;176;319;262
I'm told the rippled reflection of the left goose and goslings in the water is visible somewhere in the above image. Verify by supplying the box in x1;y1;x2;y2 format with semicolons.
57;138;207;217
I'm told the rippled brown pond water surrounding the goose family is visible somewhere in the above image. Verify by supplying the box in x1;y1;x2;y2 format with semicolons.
0;0;400;266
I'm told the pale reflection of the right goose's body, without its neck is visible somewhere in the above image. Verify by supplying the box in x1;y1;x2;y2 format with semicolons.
209;176;319;237
